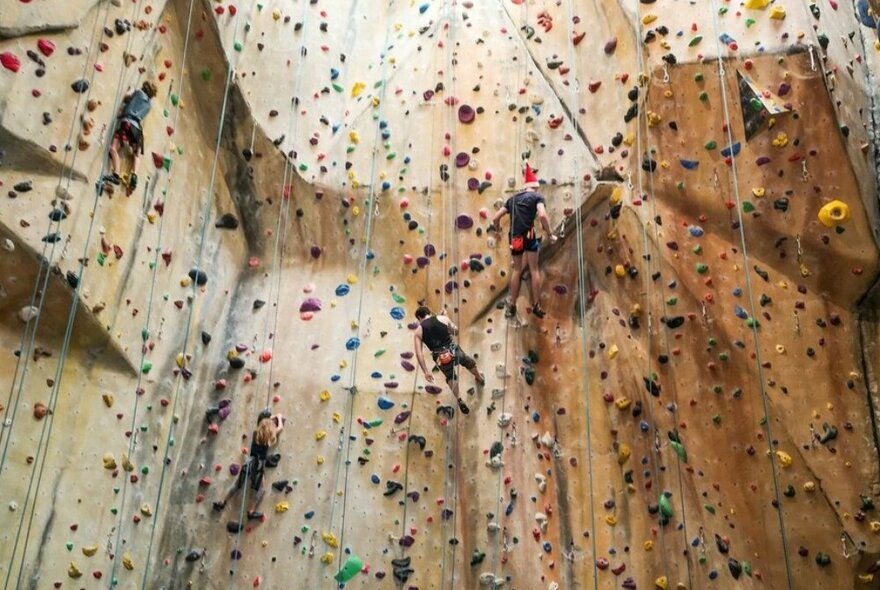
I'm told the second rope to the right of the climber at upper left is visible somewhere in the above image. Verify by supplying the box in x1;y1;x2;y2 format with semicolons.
141;0;253;590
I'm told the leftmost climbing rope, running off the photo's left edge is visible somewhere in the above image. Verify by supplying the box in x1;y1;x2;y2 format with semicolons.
0;3;117;481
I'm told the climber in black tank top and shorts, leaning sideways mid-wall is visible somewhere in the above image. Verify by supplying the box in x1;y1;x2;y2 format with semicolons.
413;306;486;414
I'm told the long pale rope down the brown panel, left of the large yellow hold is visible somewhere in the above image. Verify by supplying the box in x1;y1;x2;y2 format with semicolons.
711;0;794;590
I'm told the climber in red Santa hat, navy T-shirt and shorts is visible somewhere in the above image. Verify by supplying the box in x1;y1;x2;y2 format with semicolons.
491;163;557;319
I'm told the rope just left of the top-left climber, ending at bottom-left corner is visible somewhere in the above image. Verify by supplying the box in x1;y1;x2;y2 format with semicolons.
4;0;153;588
